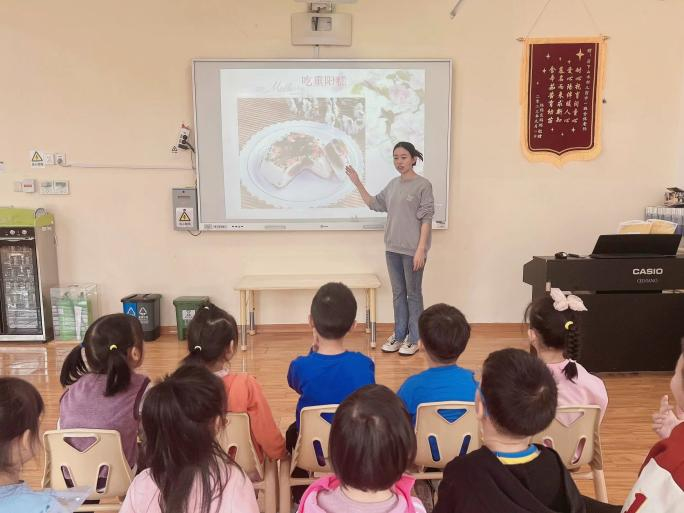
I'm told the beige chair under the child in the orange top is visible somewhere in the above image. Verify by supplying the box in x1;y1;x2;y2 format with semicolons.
218;413;278;513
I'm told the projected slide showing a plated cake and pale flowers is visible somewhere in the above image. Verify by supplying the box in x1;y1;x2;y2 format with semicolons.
221;69;425;219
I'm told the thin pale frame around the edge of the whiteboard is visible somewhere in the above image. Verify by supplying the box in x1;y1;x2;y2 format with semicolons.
192;58;453;232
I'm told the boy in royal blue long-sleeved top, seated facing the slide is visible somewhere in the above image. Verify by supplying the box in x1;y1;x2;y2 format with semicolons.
285;283;375;452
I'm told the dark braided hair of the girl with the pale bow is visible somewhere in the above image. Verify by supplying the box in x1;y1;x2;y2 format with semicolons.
525;295;582;381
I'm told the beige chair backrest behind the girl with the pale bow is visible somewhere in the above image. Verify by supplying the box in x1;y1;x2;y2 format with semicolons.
532;406;603;469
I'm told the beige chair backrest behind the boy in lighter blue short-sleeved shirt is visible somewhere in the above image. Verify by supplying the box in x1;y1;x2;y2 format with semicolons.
415;401;482;468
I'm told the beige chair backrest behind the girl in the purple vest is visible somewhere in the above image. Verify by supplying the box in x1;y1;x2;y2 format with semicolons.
43;429;133;499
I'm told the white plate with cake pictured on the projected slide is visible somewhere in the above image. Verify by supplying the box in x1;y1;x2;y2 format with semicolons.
240;121;363;208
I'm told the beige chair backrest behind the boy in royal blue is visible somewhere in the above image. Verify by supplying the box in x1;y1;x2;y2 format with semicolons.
290;404;338;473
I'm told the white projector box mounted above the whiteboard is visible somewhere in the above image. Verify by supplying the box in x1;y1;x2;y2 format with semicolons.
292;12;352;46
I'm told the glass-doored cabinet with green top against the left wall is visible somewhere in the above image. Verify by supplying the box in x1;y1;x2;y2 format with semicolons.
0;207;59;342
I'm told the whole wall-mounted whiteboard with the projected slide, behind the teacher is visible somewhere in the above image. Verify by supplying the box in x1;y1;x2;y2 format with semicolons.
193;60;451;230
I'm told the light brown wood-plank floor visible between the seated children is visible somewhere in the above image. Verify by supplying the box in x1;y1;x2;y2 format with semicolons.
0;325;675;503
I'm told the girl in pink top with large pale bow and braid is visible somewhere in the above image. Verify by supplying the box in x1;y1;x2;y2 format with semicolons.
525;289;608;425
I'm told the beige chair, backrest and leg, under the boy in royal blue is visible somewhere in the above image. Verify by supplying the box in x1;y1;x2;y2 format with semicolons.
279;404;338;513
